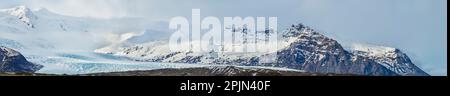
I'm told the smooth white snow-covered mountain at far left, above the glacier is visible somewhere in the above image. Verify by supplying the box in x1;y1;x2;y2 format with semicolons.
0;6;168;52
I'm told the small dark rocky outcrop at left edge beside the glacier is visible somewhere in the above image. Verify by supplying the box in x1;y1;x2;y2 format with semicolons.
0;46;43;73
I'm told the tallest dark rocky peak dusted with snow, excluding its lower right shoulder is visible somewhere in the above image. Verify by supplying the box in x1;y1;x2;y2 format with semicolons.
277;24;398;76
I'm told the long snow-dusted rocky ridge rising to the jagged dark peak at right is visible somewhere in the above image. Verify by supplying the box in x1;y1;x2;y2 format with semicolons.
97;24;428;76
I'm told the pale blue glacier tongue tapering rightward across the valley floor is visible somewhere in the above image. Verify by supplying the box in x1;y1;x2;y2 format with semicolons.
27;53;210;74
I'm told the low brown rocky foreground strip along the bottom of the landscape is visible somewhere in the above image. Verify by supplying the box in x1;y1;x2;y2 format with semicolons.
0;66;352;76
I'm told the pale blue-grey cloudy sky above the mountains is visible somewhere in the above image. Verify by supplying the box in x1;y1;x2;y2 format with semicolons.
0;0;447;75
